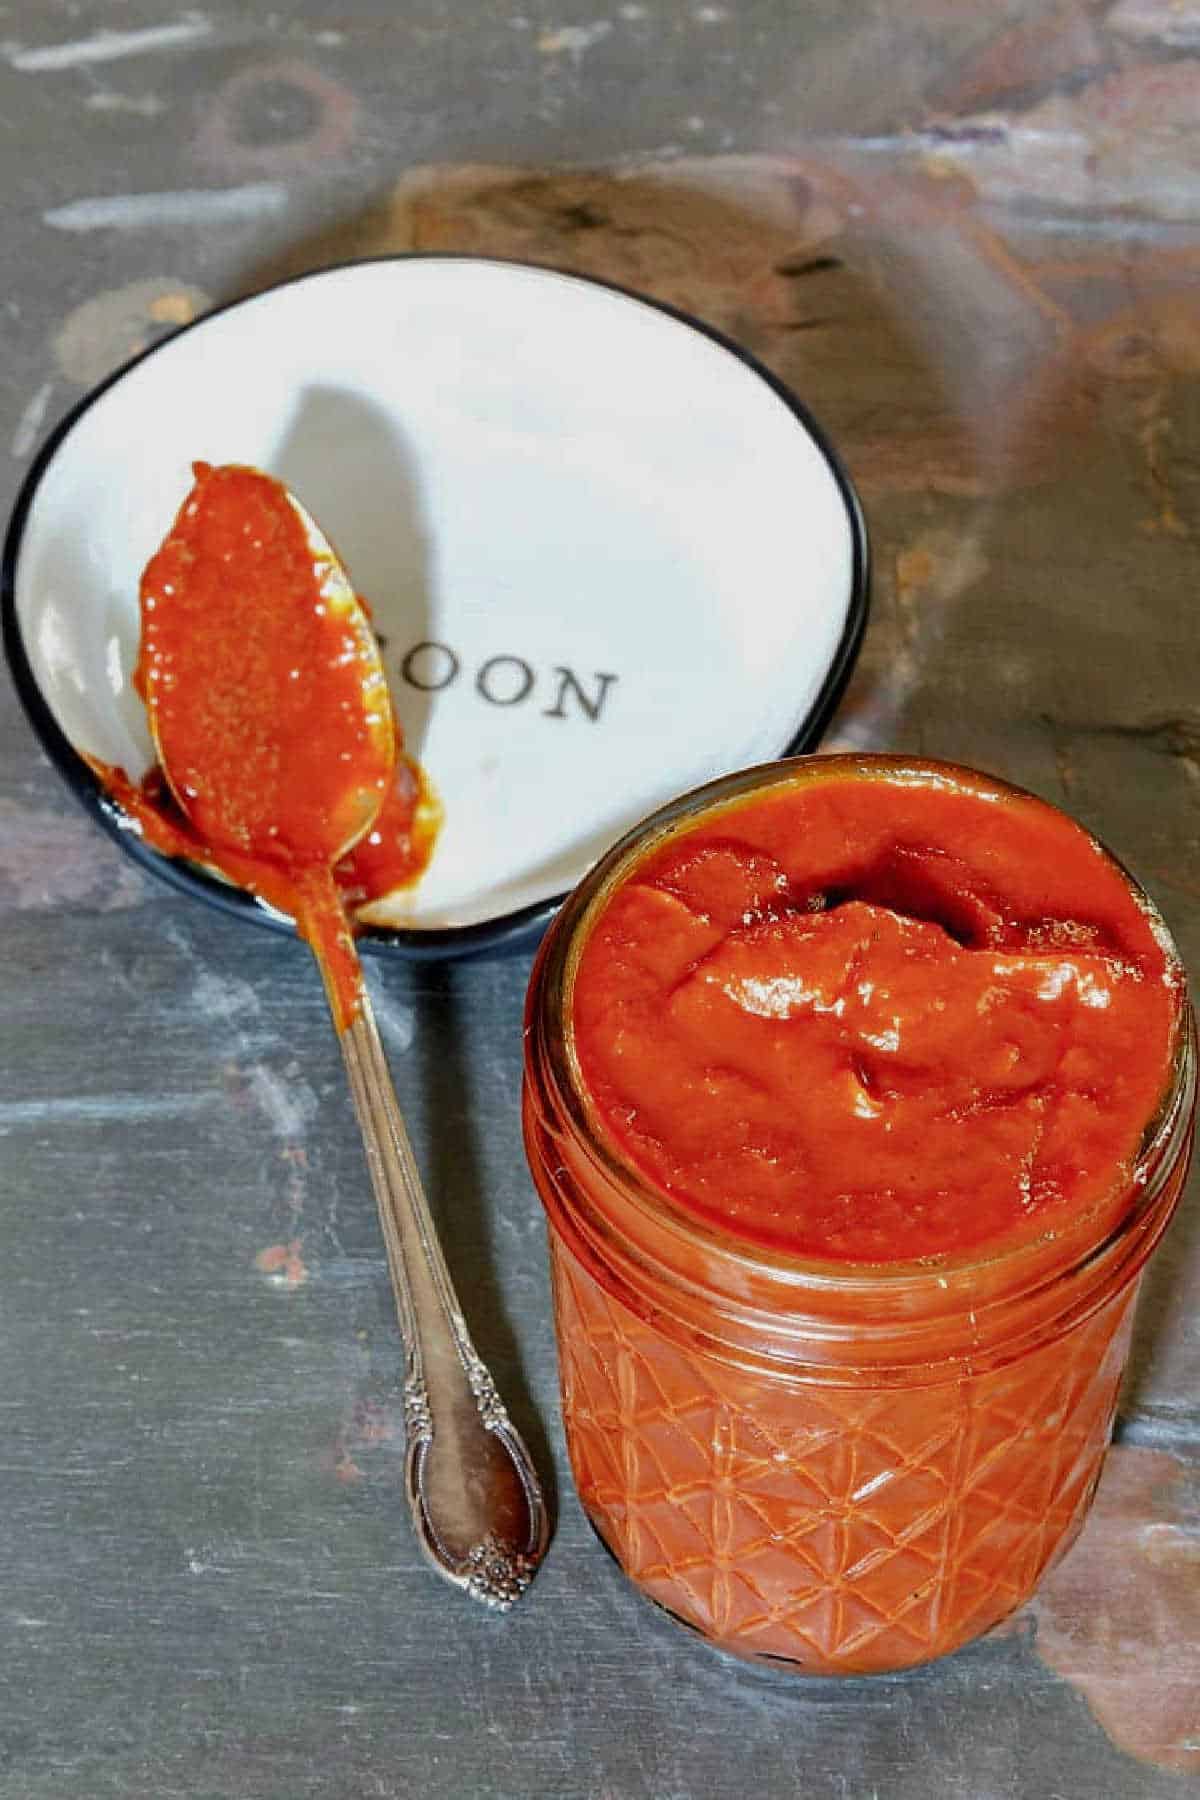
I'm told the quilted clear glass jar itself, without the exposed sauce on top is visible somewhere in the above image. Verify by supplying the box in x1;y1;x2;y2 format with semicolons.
524;758;1196;1674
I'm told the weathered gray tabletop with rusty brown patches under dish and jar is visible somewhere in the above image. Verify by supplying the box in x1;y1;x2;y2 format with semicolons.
0;0;1200;1800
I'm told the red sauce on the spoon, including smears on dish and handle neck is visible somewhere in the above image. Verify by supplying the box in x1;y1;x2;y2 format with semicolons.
94;463;437;1028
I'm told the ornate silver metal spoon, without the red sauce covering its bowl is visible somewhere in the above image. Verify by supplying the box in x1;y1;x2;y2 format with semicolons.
146;475;549;1611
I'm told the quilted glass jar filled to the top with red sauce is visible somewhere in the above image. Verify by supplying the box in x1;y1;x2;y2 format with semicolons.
525;756;1195;1672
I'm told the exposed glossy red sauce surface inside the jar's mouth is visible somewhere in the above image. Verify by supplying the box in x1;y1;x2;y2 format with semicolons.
572;774;1180;1262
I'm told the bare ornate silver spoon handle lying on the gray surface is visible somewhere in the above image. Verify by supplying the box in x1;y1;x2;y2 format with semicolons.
338;992;549;1611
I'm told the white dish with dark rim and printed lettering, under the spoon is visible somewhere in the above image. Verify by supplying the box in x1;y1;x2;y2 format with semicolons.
4;256;867;956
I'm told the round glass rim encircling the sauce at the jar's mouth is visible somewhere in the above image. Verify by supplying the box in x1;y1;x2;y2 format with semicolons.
527;751;1196;1300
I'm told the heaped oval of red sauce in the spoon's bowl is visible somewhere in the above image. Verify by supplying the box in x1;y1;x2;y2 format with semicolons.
135;464;396;871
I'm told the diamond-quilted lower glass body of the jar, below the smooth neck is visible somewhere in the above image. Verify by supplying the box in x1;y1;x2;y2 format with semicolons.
552;1233;1133;1674
